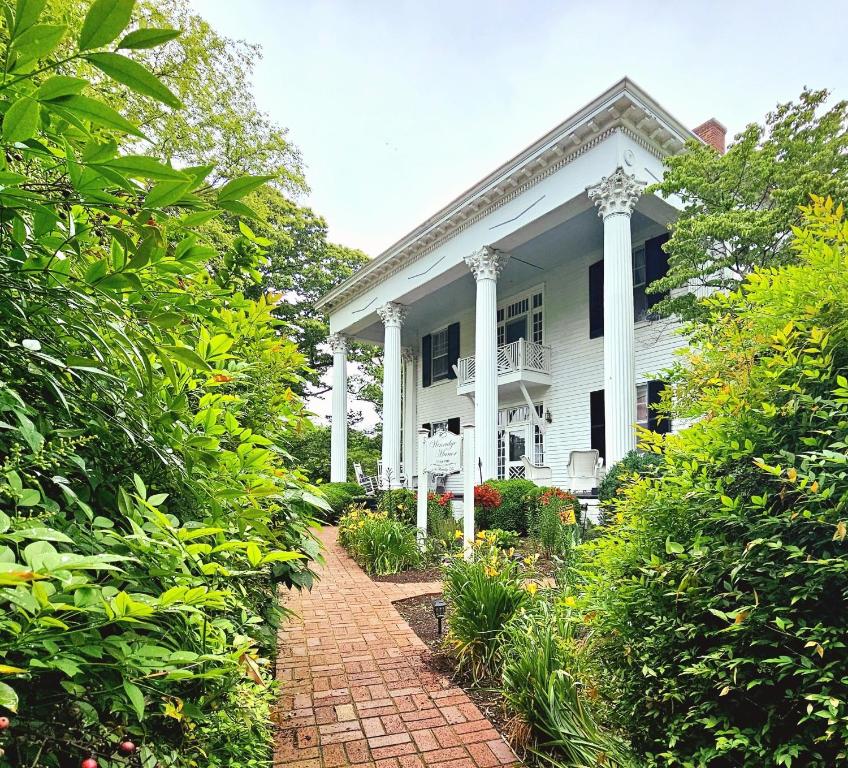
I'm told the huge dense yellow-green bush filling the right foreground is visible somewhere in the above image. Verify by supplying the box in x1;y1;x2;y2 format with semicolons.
591;199;848;768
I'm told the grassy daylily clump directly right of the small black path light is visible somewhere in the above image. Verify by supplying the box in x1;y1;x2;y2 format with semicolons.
444;537;528;680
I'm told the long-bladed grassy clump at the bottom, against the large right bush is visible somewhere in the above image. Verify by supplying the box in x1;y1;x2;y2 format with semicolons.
502;599;630;768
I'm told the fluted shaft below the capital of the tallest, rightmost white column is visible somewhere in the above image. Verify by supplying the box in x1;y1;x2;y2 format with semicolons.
604;213;636;466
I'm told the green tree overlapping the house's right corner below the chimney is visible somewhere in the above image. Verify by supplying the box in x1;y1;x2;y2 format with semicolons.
651;90;848;319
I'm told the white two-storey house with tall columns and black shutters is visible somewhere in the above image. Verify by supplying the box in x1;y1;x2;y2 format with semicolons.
318;78;724;496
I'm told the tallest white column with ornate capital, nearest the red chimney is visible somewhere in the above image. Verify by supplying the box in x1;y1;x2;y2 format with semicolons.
587;168;645;466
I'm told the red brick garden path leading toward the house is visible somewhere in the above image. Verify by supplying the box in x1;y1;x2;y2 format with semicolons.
275;528;517;768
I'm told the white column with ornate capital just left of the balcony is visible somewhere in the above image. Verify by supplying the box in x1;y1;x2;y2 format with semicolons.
465;246;509;480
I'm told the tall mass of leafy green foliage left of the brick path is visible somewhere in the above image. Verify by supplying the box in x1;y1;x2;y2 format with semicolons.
0;0;323;768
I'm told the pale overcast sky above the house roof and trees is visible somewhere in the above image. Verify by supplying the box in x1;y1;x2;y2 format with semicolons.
192;0;848;256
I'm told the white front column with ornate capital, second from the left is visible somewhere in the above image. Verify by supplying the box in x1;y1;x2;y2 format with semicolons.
377;301;406;488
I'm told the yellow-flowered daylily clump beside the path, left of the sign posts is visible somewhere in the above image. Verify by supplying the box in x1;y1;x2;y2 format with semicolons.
339;506;421;576
